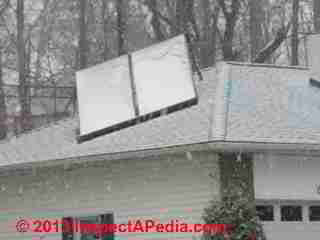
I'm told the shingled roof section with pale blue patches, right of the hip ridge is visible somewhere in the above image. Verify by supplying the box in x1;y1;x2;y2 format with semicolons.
226;62;320;144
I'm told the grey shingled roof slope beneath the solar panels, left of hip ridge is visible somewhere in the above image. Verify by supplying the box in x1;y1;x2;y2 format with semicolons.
0;69;216;166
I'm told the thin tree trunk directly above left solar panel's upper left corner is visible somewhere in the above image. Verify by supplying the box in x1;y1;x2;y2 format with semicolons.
79;0;88;69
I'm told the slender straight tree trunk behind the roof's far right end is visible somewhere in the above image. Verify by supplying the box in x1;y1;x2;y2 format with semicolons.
291;0;299;66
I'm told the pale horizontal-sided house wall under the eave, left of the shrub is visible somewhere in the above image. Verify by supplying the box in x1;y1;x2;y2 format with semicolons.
0;152;219;240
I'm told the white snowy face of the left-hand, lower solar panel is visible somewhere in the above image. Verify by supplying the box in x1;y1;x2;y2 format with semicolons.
77;56;135;135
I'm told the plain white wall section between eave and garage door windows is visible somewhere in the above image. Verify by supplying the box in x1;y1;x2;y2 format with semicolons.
254;154;320;201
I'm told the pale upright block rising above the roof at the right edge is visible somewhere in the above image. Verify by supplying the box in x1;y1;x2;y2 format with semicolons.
308;34;320;81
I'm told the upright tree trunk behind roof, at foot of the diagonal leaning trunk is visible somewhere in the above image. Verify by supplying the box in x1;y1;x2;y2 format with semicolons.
249;0;265;61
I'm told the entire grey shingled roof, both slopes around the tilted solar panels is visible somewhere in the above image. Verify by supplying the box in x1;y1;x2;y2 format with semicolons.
0;63;320;167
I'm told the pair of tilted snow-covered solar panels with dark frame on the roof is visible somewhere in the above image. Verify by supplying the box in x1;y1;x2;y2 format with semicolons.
76;35;197;142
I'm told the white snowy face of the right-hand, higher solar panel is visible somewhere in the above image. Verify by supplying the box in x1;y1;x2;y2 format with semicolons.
132;35;196;115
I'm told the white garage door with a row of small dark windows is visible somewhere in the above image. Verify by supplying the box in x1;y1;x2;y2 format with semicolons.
256;200;320;240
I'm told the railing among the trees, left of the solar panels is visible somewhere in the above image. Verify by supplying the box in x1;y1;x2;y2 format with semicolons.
0;84;76;136
